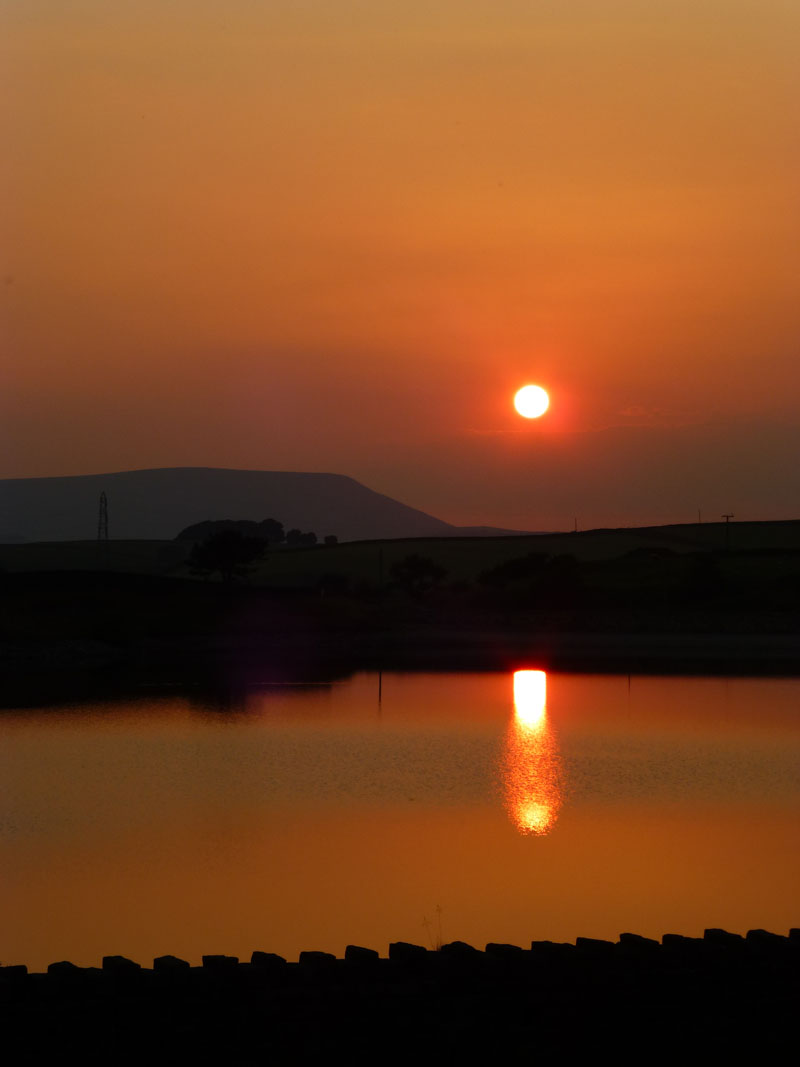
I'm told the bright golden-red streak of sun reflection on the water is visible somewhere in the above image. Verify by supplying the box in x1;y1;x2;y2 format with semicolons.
503;670;563;837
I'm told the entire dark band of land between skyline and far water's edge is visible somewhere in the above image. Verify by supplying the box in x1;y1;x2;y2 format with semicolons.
0;522;800;687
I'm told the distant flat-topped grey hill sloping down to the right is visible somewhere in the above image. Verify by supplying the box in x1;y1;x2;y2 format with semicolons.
0;467;533;543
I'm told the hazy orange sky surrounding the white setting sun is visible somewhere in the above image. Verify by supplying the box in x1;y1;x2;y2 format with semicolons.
0;0;800;529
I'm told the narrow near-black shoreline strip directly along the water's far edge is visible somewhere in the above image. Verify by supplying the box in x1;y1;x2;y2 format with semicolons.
0;626;800;707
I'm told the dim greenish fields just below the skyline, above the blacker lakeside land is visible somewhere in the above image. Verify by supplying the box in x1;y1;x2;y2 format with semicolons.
0;521;800;590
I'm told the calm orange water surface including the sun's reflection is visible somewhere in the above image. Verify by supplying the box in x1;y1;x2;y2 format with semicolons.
0;672;800;969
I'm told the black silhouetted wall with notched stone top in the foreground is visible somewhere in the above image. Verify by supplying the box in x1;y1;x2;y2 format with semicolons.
0;929;800;1064
